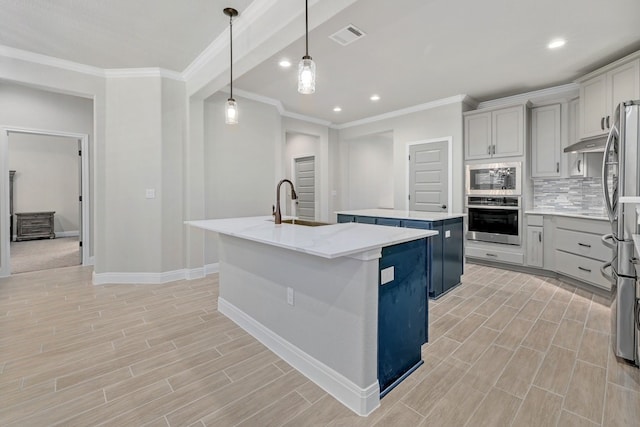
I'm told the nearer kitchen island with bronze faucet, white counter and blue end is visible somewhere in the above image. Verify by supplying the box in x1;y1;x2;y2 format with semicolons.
187;217;437;415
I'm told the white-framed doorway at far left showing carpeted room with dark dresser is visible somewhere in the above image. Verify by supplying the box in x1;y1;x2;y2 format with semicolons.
0;127;89;277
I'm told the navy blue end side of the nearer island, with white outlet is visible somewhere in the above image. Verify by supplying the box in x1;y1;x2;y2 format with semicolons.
378;239;429;397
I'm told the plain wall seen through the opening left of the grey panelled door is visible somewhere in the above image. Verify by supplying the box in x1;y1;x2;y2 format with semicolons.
344;132;394;209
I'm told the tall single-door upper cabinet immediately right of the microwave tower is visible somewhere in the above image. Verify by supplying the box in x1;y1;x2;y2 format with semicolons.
531;104;562;178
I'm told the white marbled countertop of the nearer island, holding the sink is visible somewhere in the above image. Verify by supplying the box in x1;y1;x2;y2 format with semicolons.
185;216;438;258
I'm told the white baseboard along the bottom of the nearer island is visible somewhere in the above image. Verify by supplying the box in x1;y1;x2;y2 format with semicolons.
218;297;380;416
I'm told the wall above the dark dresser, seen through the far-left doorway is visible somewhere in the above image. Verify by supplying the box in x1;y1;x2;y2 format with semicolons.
9;133;80;236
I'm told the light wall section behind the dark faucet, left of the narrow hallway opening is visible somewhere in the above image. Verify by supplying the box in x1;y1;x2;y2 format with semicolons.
204;93;283;264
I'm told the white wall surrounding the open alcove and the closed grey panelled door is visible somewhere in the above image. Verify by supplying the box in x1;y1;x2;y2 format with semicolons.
337;102;464;213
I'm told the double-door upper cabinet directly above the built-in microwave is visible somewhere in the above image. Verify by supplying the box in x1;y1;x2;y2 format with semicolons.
464;105;525;160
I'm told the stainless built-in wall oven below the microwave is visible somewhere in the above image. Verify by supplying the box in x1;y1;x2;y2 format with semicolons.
467;196;522;245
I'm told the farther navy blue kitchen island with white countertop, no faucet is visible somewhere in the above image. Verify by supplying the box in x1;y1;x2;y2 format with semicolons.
336;209;466;298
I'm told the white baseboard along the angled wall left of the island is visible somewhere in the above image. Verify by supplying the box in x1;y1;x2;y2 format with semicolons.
92;259;220;285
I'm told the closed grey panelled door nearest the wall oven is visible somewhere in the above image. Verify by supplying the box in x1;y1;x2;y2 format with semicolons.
409;141;449;212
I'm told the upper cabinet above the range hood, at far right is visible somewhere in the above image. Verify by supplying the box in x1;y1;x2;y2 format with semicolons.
580;59;640;138
